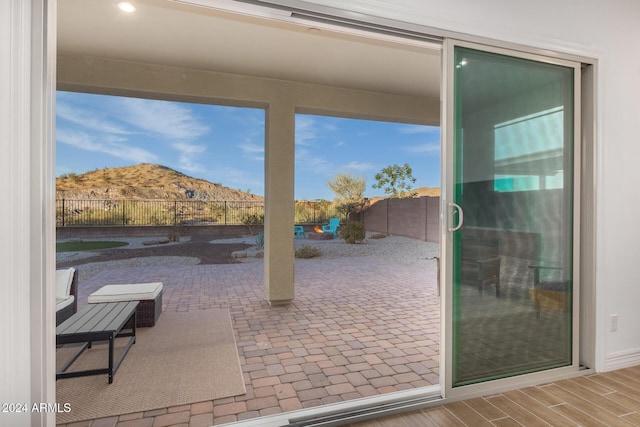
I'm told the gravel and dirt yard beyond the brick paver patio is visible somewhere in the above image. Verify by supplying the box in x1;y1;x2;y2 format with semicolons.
57;233;439;280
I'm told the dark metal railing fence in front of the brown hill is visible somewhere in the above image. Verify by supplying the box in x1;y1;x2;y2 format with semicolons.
56;199;337;227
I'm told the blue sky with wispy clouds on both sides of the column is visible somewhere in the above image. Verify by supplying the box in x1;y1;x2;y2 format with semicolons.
56;92;440;200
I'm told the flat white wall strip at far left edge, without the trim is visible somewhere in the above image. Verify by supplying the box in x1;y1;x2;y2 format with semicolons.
0;1;31;425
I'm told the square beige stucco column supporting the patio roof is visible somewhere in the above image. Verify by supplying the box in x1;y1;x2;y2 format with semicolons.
264;103;295;305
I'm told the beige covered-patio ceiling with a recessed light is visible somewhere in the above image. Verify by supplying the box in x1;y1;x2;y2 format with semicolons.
57;0;440;97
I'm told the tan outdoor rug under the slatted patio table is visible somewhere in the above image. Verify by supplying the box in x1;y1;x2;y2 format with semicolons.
56;309;246;424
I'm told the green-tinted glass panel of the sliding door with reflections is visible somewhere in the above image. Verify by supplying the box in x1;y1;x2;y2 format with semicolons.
452;47;574;387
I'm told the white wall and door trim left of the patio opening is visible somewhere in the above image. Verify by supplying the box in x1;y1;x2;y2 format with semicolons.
0;0;55;426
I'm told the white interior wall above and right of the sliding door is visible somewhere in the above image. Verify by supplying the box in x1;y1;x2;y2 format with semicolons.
292;0;640;370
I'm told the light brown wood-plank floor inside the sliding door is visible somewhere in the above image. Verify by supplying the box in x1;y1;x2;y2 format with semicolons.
351;366;640;427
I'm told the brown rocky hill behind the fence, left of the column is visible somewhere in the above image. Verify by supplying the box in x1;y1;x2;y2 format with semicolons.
56;163;263;201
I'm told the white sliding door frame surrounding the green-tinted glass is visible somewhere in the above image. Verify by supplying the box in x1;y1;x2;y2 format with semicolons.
440;37;595;400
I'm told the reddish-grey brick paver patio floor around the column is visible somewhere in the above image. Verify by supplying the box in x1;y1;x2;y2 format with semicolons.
57;257;440;427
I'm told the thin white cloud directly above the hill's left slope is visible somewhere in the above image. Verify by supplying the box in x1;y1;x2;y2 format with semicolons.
56;128;158;163
